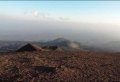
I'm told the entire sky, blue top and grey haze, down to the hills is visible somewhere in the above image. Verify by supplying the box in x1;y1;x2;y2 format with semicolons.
0;1;120;43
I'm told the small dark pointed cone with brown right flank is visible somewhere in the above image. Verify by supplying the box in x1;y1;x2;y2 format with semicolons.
16;43;42;52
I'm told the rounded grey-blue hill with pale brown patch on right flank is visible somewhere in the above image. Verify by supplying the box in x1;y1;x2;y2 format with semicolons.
40;38;81;50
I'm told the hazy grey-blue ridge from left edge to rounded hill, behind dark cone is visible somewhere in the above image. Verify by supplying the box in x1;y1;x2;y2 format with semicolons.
0;38;80;52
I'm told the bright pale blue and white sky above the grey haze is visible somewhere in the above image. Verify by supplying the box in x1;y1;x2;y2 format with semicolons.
0;1;120;25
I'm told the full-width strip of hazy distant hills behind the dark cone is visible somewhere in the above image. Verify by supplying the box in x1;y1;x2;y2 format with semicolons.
0;38;120;53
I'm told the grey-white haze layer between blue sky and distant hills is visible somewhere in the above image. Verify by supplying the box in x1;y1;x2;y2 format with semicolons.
0;14;120;44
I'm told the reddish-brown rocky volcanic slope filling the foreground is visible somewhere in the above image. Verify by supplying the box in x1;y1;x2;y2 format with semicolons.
0;51;120;82
